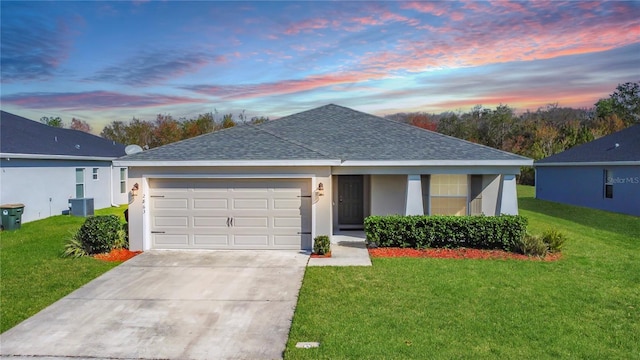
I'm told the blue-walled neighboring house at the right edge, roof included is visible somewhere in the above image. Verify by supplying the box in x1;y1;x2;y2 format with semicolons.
534;125;640;216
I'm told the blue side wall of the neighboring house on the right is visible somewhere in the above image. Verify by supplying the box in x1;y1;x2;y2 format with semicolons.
536;165;640;216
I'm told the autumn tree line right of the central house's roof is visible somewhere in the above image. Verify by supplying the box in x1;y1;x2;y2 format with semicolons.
386;82;640;184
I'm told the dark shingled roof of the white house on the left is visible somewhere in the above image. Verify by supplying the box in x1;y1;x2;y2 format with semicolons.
0;111;125;159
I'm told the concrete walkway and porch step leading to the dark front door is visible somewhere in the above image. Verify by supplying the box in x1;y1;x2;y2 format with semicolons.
308;231;371;266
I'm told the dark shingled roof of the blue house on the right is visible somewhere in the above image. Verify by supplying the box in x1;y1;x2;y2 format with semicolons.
535;124;640;166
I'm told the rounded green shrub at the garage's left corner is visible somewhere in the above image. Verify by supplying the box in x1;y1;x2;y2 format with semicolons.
77;215;124;255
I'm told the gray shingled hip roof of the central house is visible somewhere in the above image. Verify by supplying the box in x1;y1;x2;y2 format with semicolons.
120;104;531;165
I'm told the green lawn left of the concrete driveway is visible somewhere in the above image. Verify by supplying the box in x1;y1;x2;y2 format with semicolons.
0;206;126;332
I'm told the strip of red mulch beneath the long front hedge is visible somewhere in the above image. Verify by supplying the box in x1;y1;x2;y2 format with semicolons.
369;248;561;261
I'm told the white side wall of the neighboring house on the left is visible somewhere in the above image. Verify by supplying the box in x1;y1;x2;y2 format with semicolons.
0;158;127;223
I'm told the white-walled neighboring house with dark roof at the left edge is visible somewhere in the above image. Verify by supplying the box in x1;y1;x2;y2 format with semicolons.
0;111;128;223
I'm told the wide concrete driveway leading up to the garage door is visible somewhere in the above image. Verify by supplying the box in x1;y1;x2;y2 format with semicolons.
0;250;308;359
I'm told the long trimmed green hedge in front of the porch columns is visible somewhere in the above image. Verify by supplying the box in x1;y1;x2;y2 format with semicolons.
364;215;527;251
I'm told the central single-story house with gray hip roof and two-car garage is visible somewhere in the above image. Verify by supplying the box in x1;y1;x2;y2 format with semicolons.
114;105;533;250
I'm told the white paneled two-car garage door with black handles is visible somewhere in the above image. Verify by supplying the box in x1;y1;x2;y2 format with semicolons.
149;179;311;249
